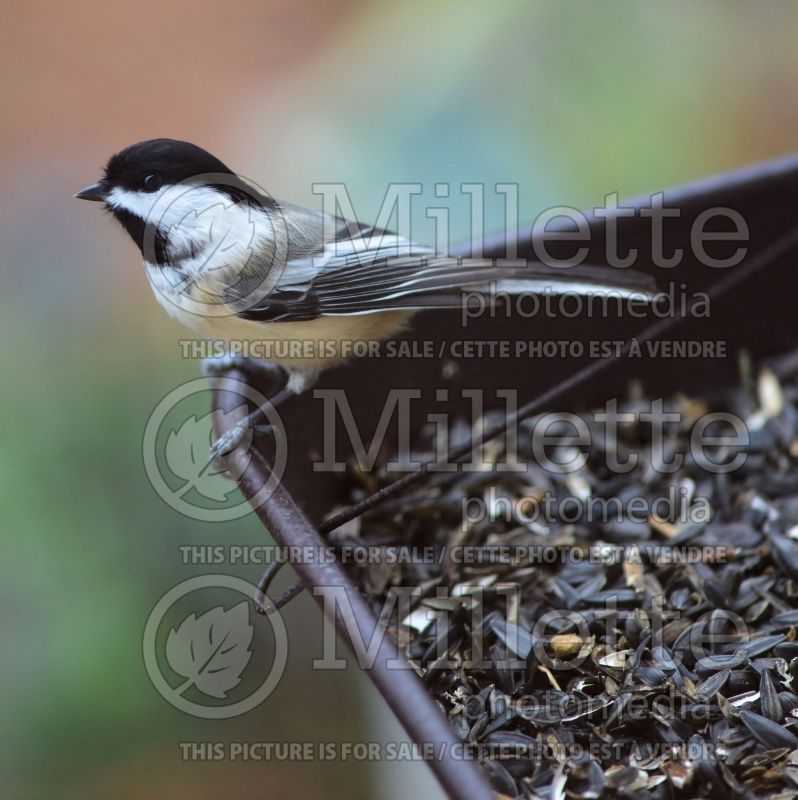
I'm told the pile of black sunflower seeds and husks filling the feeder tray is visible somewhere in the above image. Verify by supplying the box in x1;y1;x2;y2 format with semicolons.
333;355;798;800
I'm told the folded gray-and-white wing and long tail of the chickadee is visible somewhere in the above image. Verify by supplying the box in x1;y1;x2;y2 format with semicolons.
228;205;656;322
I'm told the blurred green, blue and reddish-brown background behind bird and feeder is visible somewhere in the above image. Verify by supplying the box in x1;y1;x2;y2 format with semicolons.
0;0;798;800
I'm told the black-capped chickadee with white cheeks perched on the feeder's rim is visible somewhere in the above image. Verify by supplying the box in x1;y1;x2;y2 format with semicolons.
75;139;654;454
